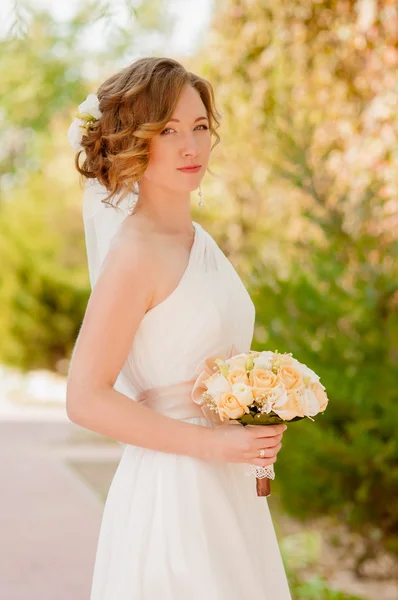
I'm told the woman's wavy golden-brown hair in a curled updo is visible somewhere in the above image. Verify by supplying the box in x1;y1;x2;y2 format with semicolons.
75;57;221;208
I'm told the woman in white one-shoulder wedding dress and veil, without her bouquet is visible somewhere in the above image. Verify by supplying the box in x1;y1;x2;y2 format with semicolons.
67;57;291;600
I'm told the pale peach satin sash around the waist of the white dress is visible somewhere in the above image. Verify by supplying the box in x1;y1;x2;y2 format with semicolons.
136;377;205;419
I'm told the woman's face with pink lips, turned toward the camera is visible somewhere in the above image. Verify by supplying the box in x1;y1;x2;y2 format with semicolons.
144;85;211;192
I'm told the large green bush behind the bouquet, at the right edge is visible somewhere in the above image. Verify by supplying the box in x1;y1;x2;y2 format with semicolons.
249;169;398;555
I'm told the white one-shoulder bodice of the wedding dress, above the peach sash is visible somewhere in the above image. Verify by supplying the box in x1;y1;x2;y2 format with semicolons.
114;222;255;398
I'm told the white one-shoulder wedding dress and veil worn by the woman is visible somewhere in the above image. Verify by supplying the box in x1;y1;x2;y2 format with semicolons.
83;185;291;600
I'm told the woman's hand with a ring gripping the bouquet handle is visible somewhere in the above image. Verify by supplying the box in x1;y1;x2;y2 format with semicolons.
205;422;287;467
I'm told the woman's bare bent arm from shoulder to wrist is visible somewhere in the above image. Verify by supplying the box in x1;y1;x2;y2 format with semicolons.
66;232;212;459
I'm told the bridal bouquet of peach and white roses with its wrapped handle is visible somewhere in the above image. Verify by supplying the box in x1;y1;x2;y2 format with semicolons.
192;346;328;496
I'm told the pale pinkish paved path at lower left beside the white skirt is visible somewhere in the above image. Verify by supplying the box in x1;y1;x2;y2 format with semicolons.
0;418;122;600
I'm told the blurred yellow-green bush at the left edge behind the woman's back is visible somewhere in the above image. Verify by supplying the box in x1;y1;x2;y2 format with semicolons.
0;170;89;369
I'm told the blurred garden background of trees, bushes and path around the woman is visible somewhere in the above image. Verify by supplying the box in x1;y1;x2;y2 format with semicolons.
0;0;398;600
